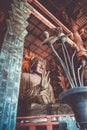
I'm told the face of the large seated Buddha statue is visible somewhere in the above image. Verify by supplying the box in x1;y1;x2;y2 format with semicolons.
36;61;46;74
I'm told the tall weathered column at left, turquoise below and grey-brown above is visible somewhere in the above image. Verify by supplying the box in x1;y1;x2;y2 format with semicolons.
0;0;29;130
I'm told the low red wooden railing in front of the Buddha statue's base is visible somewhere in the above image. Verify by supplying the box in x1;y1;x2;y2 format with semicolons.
16;114;74;130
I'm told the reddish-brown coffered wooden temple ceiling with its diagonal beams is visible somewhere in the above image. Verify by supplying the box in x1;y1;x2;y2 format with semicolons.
0;0;87;61
